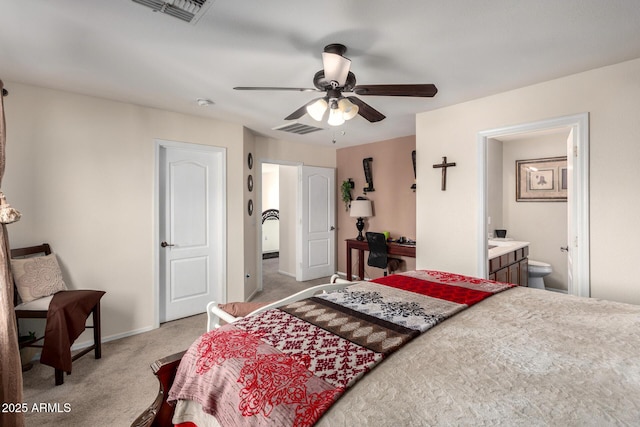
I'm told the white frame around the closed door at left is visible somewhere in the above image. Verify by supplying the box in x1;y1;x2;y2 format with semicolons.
152;139;227;328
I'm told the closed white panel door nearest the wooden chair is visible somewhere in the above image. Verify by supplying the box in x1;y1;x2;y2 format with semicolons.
159;146;226;322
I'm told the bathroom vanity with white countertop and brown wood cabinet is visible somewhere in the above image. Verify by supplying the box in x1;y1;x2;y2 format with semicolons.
489;241;529;286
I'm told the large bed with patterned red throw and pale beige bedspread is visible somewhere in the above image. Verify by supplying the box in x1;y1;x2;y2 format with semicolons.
134;271;640;427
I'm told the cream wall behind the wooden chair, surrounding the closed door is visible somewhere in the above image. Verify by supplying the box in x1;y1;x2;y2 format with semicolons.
2;82;335;344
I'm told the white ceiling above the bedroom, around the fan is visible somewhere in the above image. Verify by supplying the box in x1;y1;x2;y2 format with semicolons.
0;0;640;147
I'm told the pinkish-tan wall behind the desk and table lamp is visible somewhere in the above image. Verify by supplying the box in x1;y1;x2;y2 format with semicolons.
336;136;416;278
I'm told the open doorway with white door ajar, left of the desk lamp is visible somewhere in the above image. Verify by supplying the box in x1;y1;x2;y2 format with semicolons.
257;160;336;296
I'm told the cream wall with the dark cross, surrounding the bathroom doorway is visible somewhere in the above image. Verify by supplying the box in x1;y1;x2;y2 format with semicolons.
416;59;640;304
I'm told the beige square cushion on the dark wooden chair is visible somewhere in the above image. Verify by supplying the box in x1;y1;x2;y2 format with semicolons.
11;254;67;303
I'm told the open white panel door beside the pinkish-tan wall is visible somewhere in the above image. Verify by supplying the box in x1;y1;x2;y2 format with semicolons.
296;166;336;282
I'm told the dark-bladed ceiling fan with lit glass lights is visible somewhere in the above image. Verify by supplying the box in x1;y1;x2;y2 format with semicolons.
234;43;438;126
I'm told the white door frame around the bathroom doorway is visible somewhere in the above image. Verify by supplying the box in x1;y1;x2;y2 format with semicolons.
477;113;591;297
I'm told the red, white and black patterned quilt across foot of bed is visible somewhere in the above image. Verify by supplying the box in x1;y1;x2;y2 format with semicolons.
168;270;513;426
